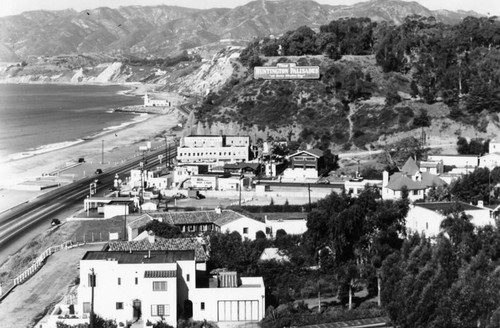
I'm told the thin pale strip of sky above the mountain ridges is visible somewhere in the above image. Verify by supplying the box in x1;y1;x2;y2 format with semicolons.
0;0;500;16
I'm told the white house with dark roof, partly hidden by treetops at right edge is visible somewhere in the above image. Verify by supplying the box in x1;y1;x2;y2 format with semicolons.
406;202;495;238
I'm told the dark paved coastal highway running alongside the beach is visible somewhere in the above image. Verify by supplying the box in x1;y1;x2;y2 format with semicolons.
0;147;177;247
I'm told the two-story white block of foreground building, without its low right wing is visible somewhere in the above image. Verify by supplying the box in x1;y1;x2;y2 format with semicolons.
78;251;190;326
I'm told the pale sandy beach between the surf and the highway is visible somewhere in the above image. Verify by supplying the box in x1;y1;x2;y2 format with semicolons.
0;85;186;213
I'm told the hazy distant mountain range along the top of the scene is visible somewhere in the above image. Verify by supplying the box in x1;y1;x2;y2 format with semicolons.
0;0;480;61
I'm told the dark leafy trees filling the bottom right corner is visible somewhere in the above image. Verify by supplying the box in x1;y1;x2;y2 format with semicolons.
382;226;500;328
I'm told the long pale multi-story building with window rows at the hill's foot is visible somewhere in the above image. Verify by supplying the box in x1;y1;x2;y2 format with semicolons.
177;135;250;170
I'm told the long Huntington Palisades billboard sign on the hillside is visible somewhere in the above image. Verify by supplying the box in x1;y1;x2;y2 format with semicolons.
253;63;319;80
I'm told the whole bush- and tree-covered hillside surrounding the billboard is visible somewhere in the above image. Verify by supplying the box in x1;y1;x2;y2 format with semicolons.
193;16;500;149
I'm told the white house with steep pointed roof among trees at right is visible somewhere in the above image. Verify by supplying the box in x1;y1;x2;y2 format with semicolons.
382;157;445;201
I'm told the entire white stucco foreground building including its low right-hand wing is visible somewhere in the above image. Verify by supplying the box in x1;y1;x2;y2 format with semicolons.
78;238;265;327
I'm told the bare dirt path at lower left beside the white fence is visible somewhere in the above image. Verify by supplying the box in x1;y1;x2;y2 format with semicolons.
0;244;102;328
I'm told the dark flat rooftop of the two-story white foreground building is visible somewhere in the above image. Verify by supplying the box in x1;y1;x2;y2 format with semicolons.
82;250;195;264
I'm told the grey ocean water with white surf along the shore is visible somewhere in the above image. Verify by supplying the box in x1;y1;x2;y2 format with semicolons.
0;84;145;162
